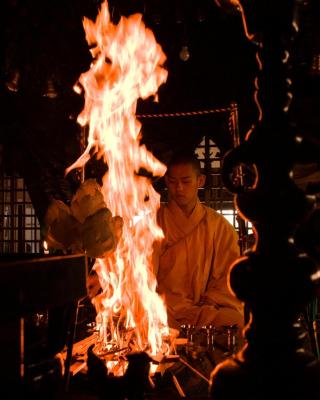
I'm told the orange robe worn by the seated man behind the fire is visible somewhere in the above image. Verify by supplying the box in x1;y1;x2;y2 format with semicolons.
155;201;243;328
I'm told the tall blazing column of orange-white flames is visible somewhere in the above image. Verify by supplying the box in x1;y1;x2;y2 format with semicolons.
66;2;169;360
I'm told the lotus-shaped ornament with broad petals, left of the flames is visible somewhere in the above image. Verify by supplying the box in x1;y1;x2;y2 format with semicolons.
45;179;122;258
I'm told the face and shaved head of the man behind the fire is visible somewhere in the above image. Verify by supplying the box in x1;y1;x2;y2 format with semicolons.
165;164;204;208
